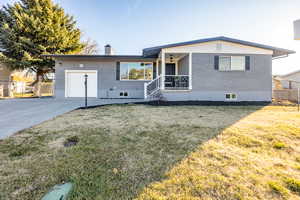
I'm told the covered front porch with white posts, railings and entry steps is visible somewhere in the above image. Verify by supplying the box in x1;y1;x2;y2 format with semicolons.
145;50;192;98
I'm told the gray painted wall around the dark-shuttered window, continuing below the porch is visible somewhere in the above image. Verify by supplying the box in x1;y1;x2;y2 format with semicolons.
163;53;272;101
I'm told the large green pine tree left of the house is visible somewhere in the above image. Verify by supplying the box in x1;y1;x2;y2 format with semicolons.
0;0;85;86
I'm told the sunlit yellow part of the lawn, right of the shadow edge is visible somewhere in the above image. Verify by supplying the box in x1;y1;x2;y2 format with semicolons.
137;106;300;200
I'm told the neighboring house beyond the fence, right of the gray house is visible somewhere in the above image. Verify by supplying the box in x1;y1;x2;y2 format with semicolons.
273;70;300;89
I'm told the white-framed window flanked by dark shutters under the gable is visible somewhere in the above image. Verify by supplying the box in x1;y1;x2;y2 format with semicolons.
219;56;246;71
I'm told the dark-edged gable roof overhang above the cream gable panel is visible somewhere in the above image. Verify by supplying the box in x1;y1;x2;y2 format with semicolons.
143;36;296;57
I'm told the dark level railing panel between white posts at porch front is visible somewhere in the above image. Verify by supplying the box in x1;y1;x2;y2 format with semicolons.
165;75;189;90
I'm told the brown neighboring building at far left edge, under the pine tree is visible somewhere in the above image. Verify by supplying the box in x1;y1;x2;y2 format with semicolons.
0;63;12;97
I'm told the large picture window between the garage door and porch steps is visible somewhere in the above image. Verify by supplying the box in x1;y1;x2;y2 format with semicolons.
120;62;153;80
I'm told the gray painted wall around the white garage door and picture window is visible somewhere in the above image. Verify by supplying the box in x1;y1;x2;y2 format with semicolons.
55;59;152;98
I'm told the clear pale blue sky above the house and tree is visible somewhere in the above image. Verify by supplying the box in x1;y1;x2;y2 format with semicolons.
0;0;300;74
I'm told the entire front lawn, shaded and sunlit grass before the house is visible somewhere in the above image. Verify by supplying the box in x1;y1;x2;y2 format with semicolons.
0;105;300;200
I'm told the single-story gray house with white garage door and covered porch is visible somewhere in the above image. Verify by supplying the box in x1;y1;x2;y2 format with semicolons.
48;36;295;101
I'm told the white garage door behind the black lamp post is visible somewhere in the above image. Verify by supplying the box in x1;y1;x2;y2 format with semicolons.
65;70;97;97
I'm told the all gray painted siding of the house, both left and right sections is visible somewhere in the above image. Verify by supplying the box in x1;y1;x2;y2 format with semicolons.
55;53;272;101
